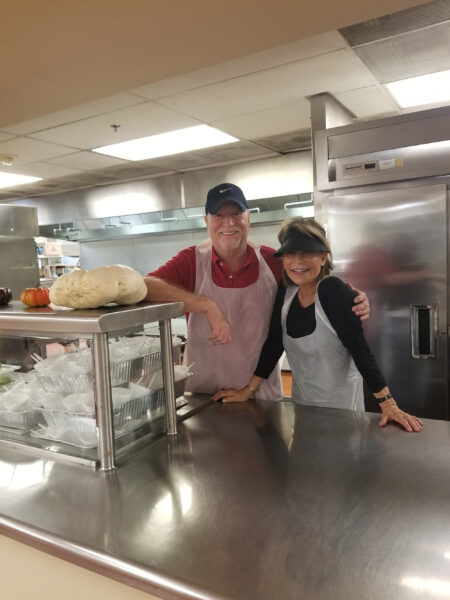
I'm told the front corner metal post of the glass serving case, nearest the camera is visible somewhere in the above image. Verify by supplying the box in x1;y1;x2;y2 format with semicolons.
92;333;116;471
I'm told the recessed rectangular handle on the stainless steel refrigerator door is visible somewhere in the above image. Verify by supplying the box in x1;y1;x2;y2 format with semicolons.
410;304;439;359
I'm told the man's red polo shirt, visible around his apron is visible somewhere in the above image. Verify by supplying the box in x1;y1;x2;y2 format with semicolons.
148;246;282;292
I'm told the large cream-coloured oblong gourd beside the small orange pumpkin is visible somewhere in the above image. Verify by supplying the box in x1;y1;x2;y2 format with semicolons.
50;265;147;308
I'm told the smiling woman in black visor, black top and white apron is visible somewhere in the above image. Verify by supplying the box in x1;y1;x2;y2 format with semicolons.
213;218;423;431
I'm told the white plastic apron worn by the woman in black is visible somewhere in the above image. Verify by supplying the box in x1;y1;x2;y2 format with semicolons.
281;283;364;411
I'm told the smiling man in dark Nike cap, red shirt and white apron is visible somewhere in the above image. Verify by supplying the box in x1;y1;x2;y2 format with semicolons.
146;183;369;400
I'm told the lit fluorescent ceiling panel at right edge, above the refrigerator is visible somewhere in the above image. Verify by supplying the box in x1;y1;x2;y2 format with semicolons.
386;70;450;108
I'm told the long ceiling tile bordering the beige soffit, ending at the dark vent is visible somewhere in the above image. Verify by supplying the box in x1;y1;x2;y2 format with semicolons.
132;31;348;100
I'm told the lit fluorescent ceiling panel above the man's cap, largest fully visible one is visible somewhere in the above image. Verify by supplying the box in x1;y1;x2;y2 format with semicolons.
93;125;239;160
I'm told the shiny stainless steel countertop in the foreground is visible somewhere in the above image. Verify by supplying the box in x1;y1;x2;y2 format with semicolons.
0;397;450;600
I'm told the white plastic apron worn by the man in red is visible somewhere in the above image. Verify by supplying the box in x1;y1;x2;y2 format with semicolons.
184;240;283;400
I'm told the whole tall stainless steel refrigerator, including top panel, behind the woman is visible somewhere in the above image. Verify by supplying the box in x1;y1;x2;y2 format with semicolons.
319;107;450;420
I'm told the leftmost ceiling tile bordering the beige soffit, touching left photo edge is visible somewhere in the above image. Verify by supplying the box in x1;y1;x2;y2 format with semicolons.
3;92;147;135
